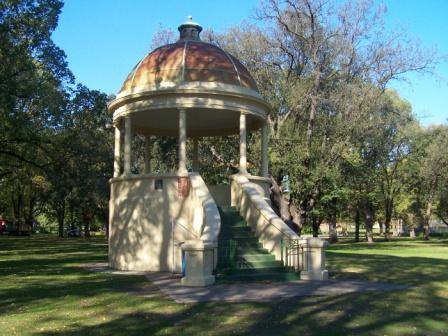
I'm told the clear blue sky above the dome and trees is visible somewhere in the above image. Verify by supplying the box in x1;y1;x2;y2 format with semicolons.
53;0;448;126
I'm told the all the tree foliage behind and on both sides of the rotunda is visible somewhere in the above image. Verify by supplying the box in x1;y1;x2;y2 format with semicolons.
0;0;448;242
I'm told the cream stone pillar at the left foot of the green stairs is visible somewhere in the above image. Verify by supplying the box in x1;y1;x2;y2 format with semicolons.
181;240;216;287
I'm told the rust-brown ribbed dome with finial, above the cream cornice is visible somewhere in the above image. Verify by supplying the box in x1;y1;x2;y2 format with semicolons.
119;19;258;94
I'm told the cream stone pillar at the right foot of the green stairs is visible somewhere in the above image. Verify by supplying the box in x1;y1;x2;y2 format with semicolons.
299;237;328;280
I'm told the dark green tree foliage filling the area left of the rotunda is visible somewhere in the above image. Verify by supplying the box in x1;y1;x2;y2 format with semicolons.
0;0;112;235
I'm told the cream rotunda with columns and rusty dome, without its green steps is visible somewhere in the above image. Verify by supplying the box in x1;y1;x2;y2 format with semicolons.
108;18;326;285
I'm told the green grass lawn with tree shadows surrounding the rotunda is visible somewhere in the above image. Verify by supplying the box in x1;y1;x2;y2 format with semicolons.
0;236;448;336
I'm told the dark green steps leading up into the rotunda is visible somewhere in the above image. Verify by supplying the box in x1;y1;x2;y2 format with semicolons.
218;206;299;282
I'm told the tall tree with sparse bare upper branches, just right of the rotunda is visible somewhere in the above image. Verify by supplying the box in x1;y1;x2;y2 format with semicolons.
211;0;434;242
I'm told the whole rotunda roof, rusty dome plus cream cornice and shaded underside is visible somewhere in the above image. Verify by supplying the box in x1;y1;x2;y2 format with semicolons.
108;18;270;137
